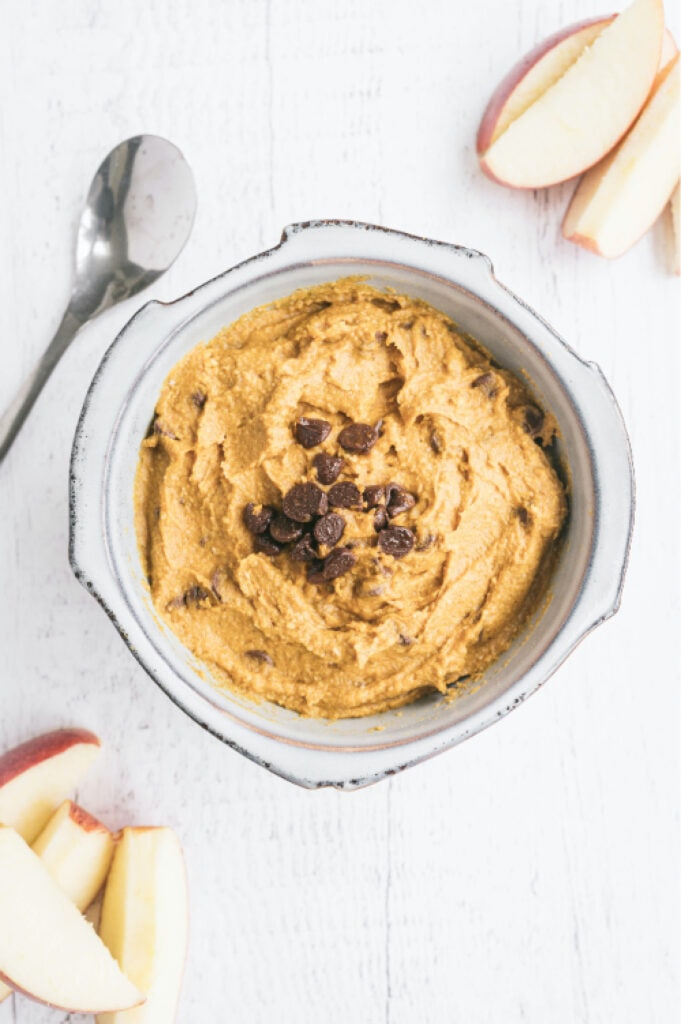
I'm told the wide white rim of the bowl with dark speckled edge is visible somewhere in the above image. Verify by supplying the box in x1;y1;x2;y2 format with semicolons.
70;220;635;788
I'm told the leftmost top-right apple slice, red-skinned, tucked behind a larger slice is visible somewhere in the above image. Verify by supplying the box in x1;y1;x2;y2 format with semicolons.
476;14;615;154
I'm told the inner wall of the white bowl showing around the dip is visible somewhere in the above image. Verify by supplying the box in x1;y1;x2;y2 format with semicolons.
104;259;594;750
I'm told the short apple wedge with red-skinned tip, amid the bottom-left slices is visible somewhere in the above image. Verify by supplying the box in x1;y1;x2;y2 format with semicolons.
0;800;114;1002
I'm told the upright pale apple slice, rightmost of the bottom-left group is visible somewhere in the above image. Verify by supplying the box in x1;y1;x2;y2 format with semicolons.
97;828;187;1024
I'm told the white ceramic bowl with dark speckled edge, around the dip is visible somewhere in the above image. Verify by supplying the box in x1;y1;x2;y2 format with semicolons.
71;221;634;788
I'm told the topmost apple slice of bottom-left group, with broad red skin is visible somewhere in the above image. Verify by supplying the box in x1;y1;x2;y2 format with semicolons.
0;729;100;843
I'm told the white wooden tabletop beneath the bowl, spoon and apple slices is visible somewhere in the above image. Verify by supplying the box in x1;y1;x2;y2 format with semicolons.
0;0;679;1024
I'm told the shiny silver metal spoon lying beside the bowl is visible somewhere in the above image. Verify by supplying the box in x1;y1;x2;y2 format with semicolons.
0;135;197;462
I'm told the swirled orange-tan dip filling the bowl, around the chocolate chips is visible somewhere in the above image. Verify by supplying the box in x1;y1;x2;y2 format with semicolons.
135;279;566;718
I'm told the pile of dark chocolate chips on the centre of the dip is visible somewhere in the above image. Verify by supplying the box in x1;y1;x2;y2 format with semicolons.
244;418;416;584
